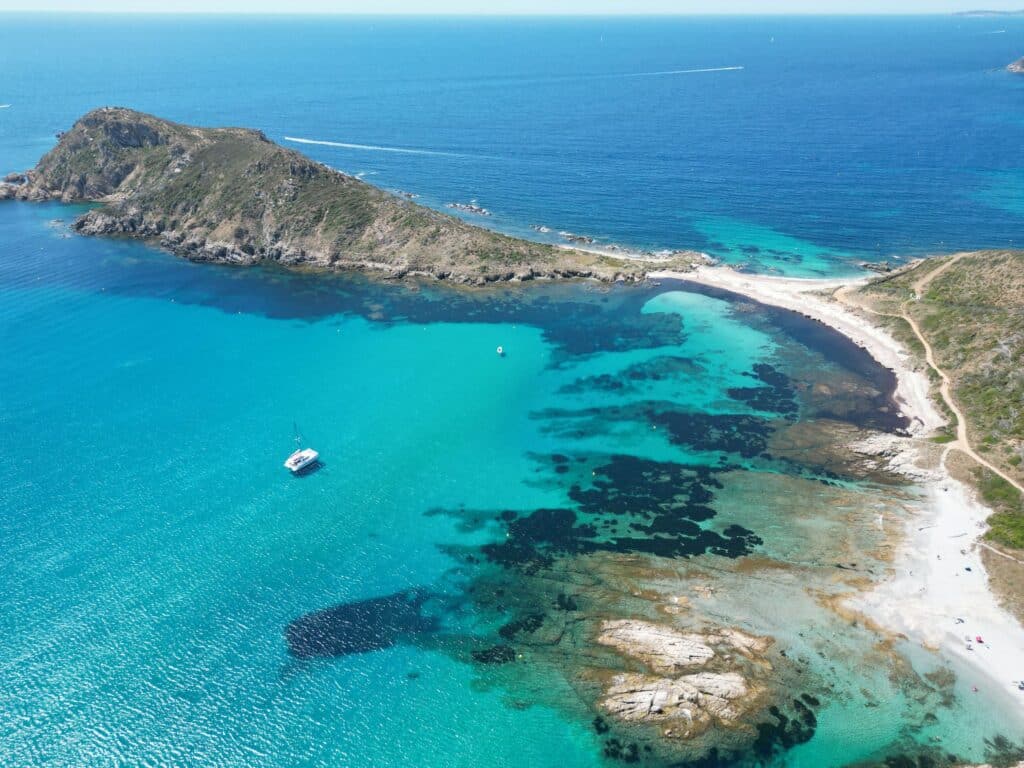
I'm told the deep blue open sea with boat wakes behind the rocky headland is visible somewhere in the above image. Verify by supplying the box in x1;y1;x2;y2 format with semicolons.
0;15;1024;272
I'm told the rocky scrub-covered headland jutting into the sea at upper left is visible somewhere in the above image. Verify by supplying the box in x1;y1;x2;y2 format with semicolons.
0;108;699;285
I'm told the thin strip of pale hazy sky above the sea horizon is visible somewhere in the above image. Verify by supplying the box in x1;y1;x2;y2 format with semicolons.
0;0;1024;14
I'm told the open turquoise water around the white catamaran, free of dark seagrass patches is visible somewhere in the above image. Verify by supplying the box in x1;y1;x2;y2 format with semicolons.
0;207;592;765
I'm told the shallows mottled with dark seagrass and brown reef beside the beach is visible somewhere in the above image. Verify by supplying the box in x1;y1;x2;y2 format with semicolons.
278;280;1015;768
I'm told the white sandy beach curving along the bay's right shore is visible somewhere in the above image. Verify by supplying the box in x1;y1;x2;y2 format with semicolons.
650;267;1024;715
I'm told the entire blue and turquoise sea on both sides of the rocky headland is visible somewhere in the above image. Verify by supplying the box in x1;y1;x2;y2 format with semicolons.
0;15;1024;768
